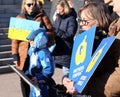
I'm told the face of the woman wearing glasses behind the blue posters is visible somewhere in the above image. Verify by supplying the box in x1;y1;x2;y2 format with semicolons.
79;10;97;31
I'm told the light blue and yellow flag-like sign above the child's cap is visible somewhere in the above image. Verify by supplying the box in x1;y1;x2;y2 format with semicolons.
8;17;40;41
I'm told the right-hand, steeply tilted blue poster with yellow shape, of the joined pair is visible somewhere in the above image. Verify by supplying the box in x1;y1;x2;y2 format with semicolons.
75;36;115;93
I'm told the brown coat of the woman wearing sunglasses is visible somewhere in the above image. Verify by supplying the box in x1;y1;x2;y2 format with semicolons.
12;10;55;70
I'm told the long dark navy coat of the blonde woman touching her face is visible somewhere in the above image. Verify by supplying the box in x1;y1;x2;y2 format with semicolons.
53;9;78;67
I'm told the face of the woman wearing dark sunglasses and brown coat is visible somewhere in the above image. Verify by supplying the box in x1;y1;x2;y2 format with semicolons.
25;0;35;14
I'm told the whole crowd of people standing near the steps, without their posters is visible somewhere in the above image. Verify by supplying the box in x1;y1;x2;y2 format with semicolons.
12;0;120;97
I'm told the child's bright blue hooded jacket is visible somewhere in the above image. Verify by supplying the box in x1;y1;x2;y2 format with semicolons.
27;30;54;82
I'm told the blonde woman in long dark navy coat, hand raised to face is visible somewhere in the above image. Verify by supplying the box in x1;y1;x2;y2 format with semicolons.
52;0;78;75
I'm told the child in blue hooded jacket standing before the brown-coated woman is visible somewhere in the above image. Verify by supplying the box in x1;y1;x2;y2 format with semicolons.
26;28;56;97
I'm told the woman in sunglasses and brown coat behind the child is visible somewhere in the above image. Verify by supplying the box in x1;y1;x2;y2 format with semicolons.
11;0;55;97
